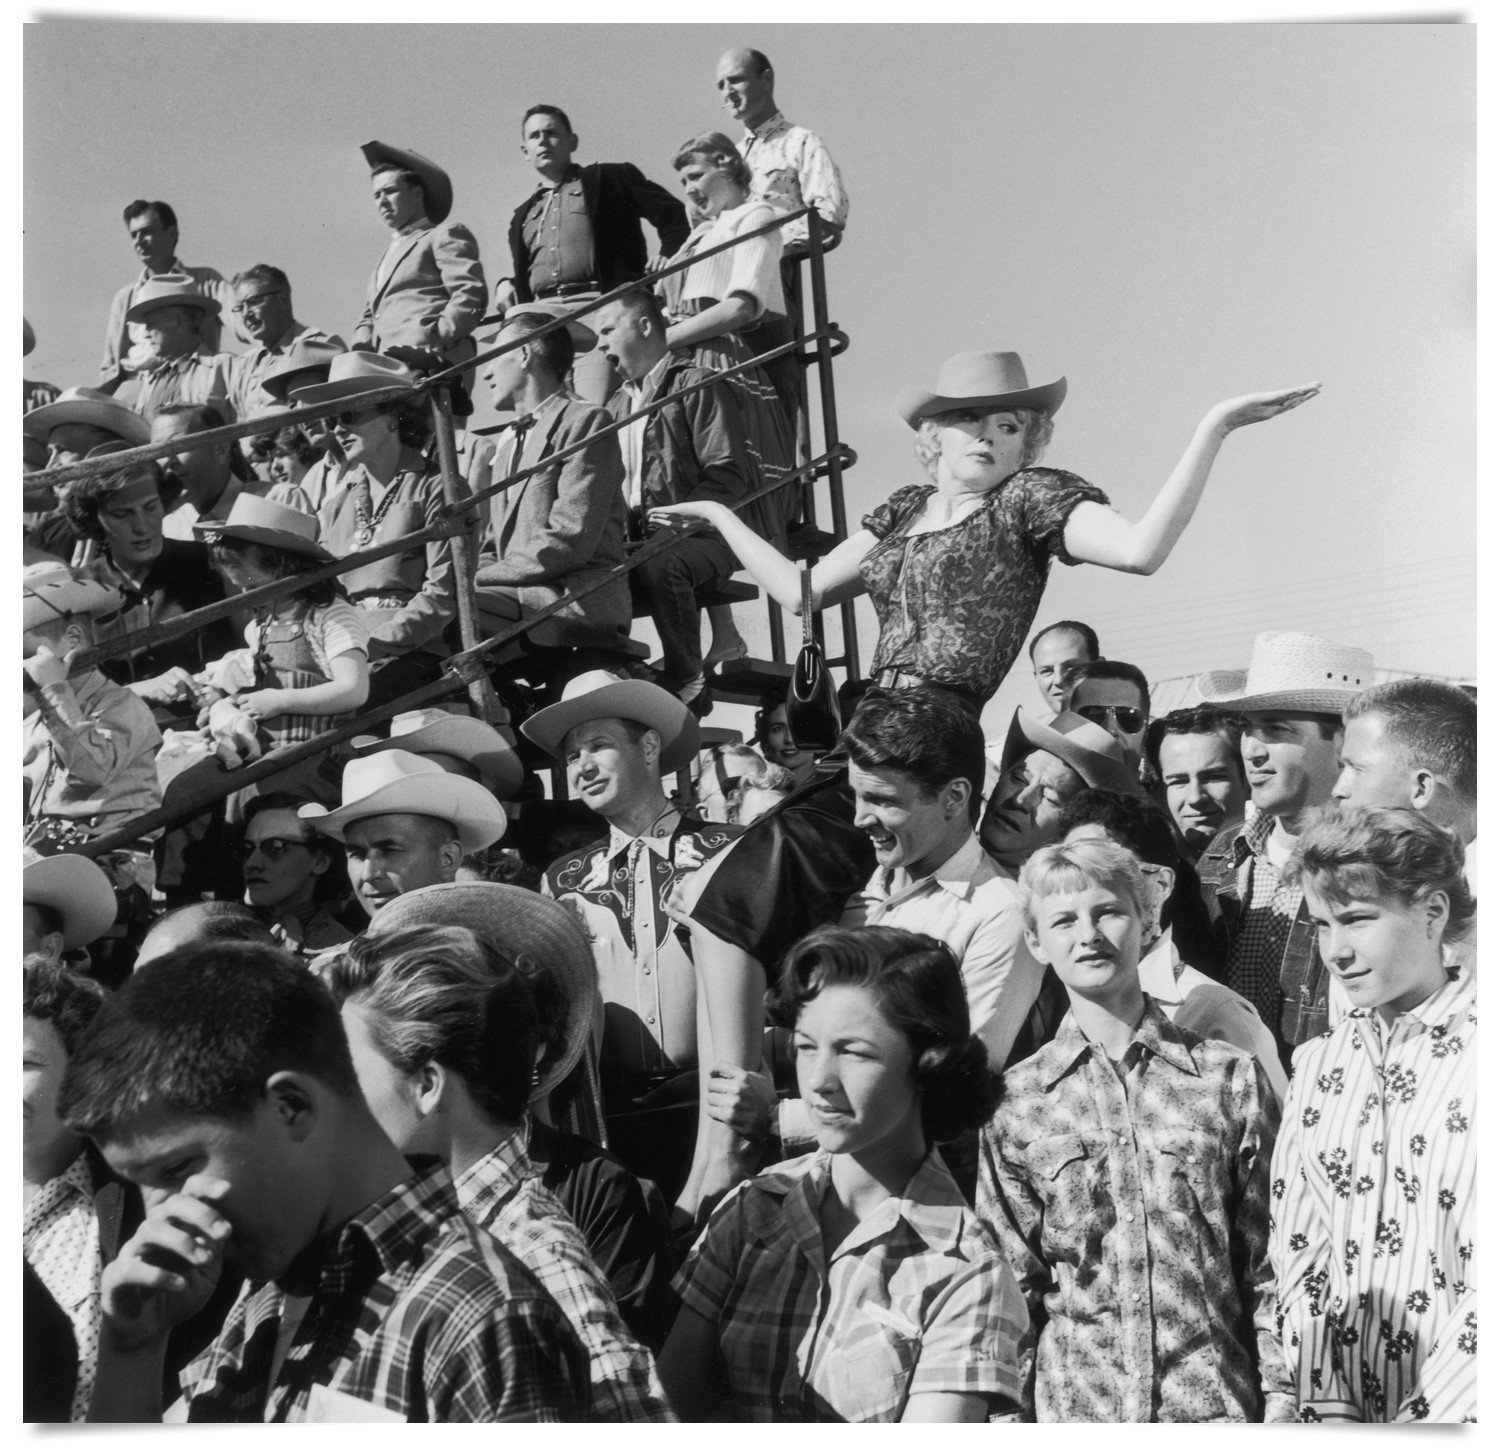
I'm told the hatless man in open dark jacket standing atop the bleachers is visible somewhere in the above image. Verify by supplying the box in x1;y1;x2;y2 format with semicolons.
495;105;689;405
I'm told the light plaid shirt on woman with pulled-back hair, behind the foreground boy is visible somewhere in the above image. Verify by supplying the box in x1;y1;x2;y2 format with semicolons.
455;1133;677;1421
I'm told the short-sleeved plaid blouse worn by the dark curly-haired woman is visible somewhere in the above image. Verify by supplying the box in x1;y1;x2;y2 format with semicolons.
674;1149;1026;1421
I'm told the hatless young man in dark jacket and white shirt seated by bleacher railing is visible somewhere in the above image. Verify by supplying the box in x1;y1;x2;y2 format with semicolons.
593;290;776;711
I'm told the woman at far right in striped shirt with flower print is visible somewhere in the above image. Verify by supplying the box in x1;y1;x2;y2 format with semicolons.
1272;804;1479;1422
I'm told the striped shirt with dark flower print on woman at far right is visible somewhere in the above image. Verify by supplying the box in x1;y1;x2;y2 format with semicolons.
1272;975;1479;1422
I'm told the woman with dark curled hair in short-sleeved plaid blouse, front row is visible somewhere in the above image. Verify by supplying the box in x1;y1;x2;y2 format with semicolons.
660;927;1026;1422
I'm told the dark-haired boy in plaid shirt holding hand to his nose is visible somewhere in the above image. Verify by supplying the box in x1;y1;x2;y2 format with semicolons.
57;941;590;1422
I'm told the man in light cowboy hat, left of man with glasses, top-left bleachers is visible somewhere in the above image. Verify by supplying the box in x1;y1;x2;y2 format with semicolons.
104;275;234;422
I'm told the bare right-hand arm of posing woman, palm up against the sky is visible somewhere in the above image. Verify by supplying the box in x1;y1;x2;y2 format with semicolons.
1062;383;1322;575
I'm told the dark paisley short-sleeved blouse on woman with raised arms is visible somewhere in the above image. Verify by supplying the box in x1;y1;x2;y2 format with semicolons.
860;467;1110;701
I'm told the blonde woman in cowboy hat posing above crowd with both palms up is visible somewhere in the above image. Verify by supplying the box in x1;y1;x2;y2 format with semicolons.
650;351;1319;1218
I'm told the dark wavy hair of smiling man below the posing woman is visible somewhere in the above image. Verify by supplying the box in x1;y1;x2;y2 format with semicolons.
840;687;984;822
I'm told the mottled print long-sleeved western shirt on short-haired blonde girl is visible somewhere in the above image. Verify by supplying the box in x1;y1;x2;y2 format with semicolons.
978;999;1295;1422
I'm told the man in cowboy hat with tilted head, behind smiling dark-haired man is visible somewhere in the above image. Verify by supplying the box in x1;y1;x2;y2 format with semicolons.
980;708;1140;879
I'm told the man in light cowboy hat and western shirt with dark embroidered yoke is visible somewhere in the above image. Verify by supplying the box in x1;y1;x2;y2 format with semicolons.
521;672;740;1200
